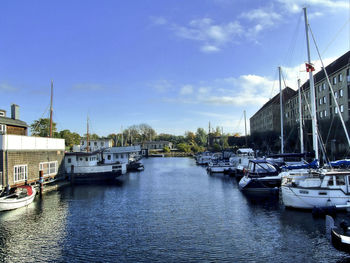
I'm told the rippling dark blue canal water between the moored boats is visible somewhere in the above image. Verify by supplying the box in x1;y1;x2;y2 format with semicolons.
0;158;348;262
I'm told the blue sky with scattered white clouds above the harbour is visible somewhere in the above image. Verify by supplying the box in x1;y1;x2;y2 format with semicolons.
0;0;350;136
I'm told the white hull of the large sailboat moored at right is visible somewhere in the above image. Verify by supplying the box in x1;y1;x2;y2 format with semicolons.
281;186;350;209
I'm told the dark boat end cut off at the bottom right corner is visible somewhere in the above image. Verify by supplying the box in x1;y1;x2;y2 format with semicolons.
326;215;350;253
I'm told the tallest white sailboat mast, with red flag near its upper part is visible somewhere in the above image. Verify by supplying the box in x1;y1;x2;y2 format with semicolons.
303;7;319;160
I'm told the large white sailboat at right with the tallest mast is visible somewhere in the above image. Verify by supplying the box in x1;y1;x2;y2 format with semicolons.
281;8;350;209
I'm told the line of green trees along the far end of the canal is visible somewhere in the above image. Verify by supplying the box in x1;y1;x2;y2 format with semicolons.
30;118;249;153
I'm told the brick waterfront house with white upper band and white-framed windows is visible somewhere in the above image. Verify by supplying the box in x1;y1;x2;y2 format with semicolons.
0;104;65;191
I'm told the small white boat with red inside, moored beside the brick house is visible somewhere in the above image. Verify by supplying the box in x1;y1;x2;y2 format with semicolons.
0;185;36;211
